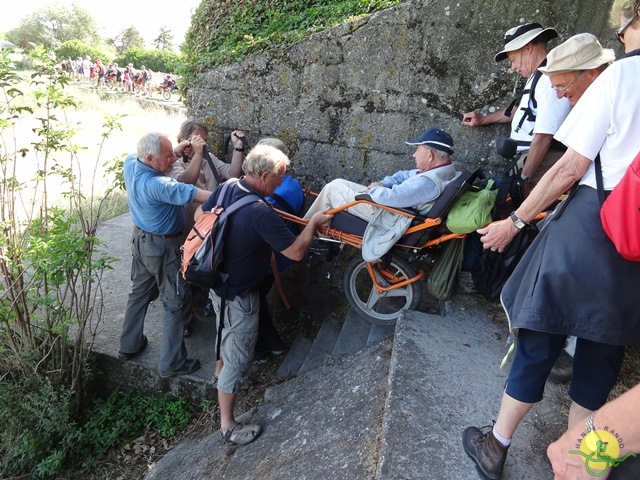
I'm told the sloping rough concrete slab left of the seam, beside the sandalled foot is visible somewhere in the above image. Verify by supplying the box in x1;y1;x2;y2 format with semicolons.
220;342;391;480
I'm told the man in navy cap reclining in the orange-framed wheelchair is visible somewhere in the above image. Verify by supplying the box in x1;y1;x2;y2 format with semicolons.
304;128;458;221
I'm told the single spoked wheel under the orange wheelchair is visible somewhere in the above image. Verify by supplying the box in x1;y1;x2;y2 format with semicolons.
343;255;421;325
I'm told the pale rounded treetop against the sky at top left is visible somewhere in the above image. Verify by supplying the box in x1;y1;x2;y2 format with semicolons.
7;1;102;50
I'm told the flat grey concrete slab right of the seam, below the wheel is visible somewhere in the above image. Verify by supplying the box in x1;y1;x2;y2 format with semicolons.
377;295;566;480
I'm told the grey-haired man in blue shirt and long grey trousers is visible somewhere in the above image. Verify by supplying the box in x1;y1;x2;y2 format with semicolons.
120;132;211;378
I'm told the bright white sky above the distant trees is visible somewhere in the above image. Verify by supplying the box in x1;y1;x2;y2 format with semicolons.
0;0;200;48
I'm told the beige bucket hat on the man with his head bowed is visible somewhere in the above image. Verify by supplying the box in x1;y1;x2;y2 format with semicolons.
538;33;616;76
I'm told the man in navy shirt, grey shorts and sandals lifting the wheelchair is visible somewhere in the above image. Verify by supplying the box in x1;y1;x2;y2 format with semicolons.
196;145;331;445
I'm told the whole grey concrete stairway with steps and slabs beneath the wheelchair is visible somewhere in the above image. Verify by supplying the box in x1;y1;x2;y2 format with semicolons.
145;295;566;480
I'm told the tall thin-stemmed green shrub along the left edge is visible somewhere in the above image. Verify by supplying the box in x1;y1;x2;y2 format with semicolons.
0;46;122;478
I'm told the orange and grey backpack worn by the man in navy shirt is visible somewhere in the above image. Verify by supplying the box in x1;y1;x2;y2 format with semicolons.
182;179;260;288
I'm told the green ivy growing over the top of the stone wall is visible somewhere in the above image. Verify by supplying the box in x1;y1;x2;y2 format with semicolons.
178;0;400;86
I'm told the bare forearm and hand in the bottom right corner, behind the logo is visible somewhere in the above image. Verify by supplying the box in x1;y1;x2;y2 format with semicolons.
547;385;640;480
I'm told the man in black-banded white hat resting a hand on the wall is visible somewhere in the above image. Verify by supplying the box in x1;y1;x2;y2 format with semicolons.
462;23;569;186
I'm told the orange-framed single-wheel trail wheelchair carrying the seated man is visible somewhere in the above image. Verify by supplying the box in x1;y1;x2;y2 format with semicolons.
278;170;481;325
